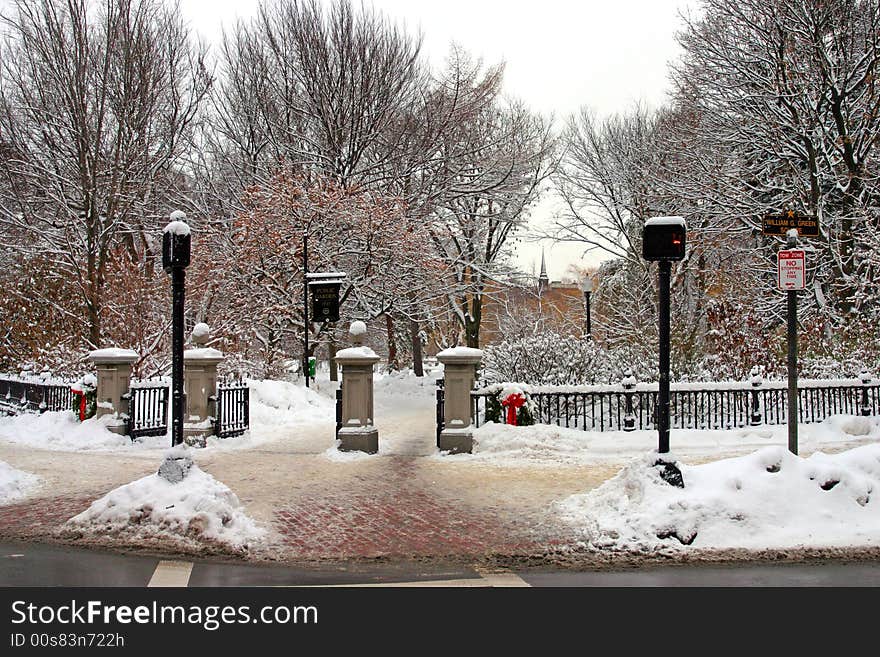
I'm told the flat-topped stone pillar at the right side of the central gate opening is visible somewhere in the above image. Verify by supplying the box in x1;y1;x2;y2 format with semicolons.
437;347;483;454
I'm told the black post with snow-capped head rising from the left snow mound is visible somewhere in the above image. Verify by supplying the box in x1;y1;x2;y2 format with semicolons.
162;210;190;447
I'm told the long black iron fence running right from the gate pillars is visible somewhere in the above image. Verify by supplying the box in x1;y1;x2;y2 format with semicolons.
468;379;880;432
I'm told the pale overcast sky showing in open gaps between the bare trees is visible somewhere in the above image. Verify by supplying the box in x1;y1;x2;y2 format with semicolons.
180;0;698;279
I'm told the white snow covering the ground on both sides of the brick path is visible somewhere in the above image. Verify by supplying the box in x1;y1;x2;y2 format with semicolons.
0;368;880;553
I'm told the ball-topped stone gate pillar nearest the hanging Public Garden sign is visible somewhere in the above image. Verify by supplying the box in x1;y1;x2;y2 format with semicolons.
336;322;379;454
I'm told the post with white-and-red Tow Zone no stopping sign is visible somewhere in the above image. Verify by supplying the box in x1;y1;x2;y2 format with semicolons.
776;228;806;455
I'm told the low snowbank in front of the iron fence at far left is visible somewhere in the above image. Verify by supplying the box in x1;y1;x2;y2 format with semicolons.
0;411;168;452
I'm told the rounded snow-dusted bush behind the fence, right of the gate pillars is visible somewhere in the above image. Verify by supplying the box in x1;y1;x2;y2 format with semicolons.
481;332;656;385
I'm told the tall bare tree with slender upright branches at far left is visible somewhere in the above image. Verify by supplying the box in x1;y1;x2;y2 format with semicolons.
0;0;210;358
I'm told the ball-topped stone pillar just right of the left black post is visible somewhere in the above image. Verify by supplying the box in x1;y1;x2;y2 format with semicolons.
183;323;224;446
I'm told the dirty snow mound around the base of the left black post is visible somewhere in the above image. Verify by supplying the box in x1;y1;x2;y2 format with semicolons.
67;448;266;549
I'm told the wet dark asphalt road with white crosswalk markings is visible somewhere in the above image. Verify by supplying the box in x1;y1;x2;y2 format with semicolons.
0;543;880;587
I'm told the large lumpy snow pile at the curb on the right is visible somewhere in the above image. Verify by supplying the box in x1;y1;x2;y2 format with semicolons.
557;444;880;553
